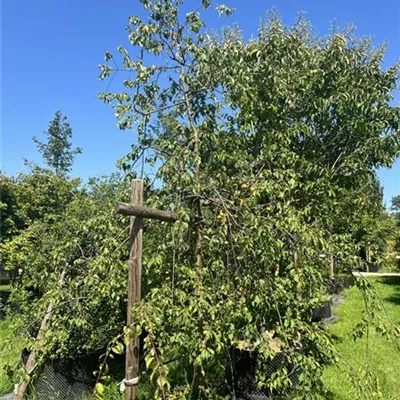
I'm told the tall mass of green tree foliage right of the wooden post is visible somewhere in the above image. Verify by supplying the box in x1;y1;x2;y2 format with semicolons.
100;0;400;399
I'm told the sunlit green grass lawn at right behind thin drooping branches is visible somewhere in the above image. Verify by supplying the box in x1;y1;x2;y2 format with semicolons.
324;277;400;400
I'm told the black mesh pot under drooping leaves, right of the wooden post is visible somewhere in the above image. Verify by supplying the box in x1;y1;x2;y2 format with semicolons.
227;348;300;400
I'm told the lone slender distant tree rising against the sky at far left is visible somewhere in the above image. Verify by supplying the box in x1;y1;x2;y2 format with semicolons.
33;111;82;174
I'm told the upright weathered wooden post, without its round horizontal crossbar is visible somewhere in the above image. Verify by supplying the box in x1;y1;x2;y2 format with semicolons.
125;179;143;400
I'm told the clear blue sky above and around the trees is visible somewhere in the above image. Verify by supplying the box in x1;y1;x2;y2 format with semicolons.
0;0;400;202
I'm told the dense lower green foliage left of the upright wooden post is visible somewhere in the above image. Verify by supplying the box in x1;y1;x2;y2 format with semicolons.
0;175;128;390
